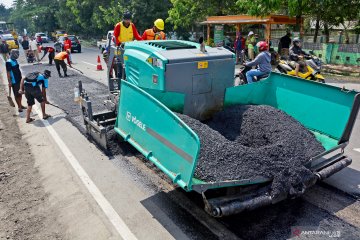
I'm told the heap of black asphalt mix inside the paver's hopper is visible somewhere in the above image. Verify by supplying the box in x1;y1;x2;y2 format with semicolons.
179;105;324;199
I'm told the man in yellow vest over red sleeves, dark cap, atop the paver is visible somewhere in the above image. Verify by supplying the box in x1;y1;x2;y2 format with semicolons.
114;12;142;46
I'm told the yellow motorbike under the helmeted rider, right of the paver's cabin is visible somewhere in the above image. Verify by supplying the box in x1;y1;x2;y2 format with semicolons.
276;55;325;83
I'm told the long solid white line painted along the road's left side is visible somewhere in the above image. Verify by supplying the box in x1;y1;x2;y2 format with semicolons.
34;105;137;240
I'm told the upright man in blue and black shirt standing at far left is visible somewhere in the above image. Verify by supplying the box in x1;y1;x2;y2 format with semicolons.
6;49;26;112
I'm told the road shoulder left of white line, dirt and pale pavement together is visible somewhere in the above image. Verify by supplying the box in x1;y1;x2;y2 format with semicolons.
0;59;119;239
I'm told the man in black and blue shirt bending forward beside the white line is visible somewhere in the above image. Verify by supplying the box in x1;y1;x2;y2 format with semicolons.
19;70;51;123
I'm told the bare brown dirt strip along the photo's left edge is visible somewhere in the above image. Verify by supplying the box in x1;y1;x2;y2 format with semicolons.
0;84;64;240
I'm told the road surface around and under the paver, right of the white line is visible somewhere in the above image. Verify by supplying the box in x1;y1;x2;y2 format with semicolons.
10;44;360;239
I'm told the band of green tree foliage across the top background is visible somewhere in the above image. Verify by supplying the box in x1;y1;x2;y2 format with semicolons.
0;0;360;41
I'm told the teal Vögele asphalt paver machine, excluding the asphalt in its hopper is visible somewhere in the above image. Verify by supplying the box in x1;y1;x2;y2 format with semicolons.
79;40;360;217
